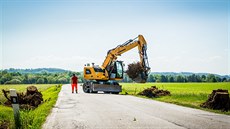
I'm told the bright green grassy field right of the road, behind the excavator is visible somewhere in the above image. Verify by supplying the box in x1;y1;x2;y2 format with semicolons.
121;83;230;115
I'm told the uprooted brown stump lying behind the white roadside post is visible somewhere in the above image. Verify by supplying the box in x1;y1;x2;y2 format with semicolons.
2;86;43;109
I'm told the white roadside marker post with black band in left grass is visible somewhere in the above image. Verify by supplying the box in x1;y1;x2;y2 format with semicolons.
10;89;21;129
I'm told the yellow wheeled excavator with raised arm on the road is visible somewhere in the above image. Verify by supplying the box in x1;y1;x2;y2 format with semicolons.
83;35;150;94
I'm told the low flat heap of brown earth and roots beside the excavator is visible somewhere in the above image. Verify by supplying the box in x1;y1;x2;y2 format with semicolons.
138;86;170;98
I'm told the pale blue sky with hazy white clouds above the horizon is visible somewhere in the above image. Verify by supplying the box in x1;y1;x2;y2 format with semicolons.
0;0;230;75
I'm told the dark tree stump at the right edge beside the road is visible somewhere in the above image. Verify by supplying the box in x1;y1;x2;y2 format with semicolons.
200;89;230;111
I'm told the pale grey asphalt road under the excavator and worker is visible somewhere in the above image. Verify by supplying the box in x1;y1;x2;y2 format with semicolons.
43;85;230;129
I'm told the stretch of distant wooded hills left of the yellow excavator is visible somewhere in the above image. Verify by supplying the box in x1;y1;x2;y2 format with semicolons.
0;68;83;84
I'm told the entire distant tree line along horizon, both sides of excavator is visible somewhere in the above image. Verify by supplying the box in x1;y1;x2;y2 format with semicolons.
0;68;230;84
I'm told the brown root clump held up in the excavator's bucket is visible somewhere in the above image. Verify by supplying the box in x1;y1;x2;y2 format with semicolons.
126;62;147;83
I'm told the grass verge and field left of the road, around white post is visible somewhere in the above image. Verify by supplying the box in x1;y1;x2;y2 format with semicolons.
0;84;61;129
